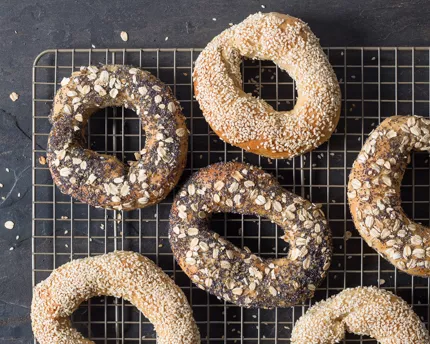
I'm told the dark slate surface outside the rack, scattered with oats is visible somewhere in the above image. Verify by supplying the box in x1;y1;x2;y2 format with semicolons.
0;0;430;343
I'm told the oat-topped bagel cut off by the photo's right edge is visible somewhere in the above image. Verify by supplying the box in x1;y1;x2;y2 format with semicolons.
348;116;430;277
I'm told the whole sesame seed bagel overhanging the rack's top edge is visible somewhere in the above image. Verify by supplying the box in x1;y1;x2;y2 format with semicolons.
194;13;341;158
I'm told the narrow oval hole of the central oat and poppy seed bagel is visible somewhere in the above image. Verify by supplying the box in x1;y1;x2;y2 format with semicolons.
209;213;289;259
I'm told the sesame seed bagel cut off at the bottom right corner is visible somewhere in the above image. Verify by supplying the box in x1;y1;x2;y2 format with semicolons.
291;287;430;344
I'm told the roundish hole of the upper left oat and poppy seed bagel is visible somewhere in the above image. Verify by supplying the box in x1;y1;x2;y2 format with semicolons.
86;107;146;164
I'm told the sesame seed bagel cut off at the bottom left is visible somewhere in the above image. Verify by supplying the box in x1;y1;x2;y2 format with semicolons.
31;251;200;344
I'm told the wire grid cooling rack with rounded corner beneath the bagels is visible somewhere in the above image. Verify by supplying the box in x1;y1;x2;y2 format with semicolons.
32;47;430;344
